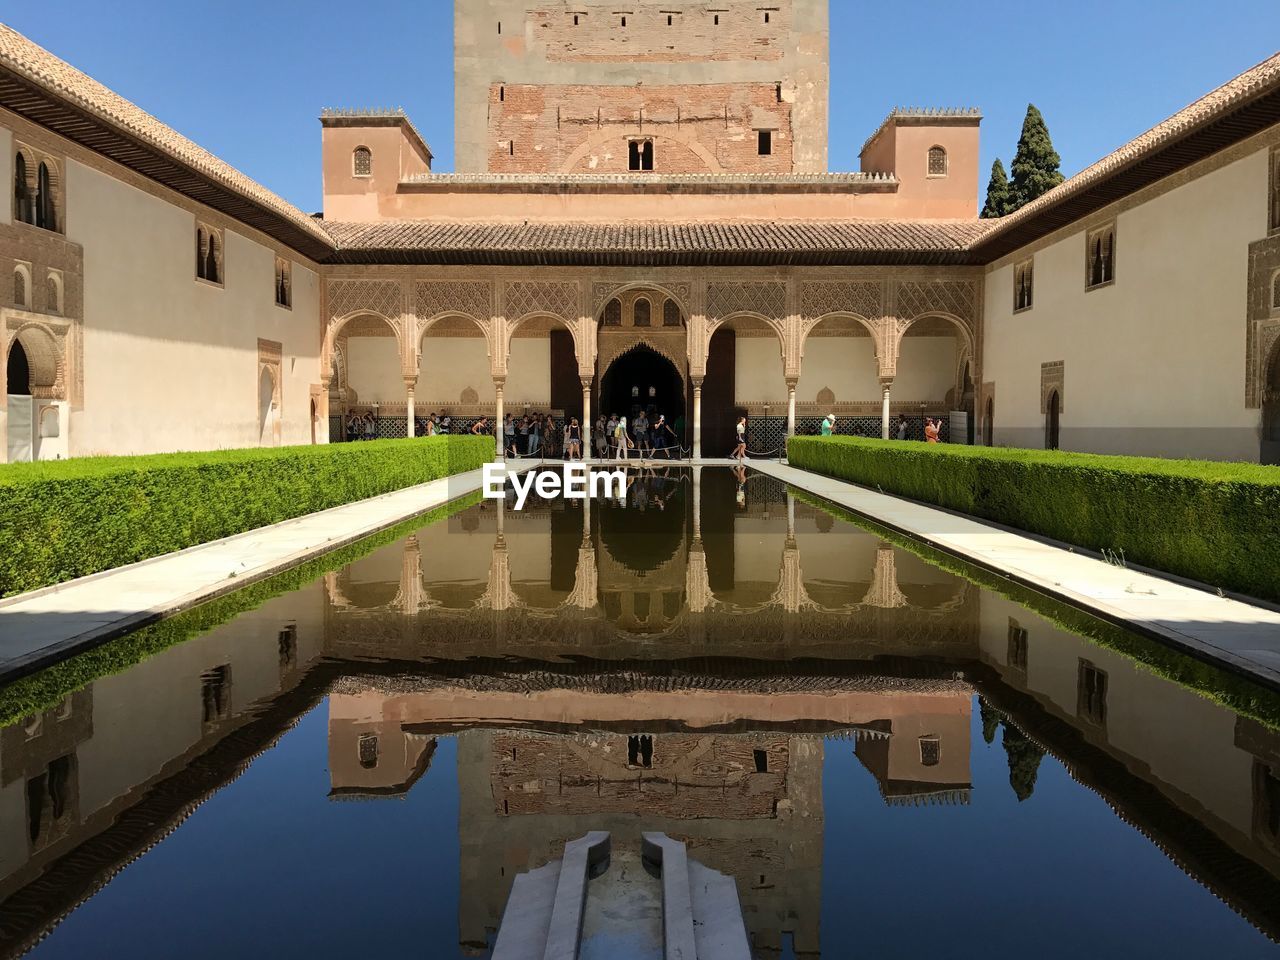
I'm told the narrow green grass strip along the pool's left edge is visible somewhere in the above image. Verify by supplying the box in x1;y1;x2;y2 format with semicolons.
0;492;481;727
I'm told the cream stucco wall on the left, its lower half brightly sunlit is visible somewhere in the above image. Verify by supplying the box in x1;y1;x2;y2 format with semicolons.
67;161;320;456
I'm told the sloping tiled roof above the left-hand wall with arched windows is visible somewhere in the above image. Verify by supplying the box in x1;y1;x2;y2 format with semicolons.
0;24;329;252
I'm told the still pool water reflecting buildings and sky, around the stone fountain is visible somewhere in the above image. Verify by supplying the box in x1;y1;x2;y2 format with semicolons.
0;468;1280;960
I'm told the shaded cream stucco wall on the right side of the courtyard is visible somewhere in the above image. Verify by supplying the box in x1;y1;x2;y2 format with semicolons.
983;150;1267;460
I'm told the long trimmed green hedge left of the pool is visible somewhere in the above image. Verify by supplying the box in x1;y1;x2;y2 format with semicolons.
0;436;494;596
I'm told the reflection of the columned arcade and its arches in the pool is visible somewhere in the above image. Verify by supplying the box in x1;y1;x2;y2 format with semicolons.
325;467;978;660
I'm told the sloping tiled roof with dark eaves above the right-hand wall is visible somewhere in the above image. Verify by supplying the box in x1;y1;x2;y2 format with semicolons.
977;54;1280;260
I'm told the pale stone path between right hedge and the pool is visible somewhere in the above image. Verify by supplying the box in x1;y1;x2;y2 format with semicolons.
749;460;1280;687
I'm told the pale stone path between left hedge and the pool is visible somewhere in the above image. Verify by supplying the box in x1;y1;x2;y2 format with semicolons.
0;462;536;681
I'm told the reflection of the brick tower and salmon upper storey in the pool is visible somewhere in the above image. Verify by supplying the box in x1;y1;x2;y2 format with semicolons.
330;668;972;955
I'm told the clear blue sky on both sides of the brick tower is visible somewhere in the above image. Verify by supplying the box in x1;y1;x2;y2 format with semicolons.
3;0;1280;211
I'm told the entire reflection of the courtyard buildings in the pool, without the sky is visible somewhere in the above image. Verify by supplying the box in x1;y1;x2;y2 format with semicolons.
0;470;1280;956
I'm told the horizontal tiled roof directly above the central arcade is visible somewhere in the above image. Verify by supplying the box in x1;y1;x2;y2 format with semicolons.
317;220;991;266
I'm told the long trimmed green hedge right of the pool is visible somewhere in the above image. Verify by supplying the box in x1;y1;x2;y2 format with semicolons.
787;436;1280;600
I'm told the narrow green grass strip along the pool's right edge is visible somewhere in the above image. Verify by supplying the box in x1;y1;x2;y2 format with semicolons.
788;486;1280;731
